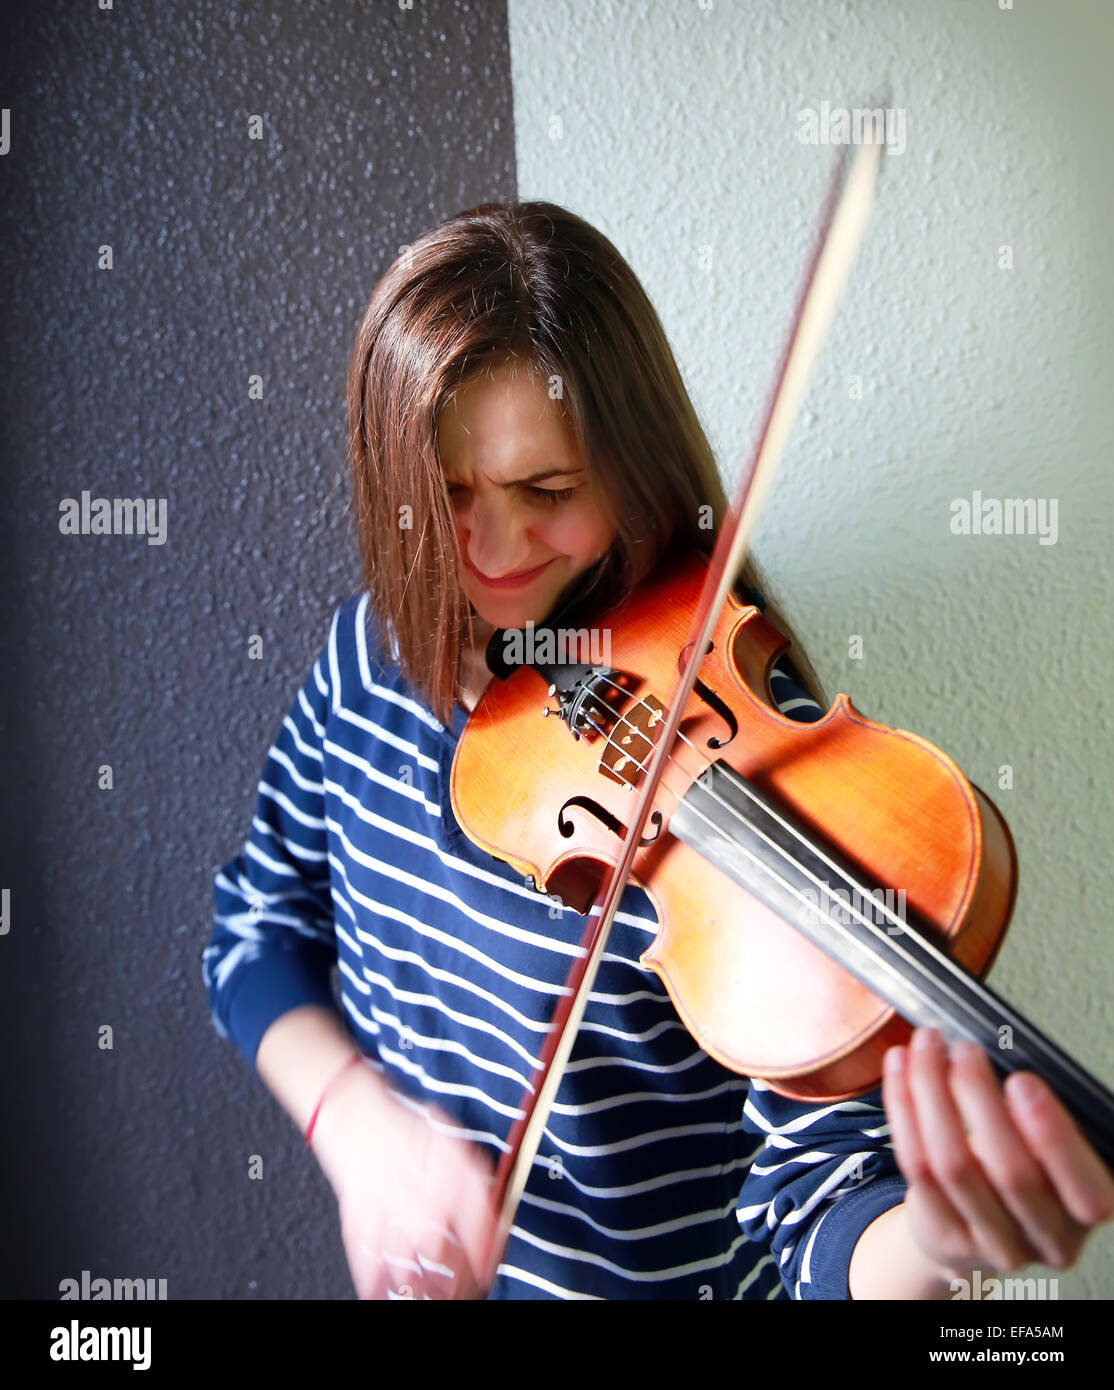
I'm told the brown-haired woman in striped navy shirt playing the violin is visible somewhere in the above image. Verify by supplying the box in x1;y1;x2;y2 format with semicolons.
204;203;1114;1298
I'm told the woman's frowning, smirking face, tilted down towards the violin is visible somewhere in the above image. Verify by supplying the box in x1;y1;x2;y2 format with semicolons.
437;364;617;628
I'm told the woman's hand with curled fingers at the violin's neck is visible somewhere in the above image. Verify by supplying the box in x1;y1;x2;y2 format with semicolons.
882;1029;1114;1279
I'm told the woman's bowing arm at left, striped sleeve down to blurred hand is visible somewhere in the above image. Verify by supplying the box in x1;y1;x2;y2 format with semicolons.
202;610;491;1298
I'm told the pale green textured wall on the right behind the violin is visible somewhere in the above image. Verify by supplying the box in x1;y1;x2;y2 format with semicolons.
508;0;1114;1298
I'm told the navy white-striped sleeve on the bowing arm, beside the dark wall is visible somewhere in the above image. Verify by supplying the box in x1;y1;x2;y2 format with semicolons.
202;614;337;1068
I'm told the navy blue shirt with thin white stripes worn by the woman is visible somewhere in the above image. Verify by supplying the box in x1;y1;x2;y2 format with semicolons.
203;594;905;1298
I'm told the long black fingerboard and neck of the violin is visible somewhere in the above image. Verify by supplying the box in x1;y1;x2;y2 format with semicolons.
669;760;1114;1168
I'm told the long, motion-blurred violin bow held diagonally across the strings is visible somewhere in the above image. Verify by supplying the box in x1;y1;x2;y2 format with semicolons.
484;119;883;1290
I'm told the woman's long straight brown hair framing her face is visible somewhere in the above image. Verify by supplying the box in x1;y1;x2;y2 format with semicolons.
348;202;828;723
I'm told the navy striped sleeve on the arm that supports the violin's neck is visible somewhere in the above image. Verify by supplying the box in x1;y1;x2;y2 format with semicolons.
736;657;907;1298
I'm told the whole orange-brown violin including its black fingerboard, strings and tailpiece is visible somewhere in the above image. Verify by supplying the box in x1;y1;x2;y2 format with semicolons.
451;550;1114;1154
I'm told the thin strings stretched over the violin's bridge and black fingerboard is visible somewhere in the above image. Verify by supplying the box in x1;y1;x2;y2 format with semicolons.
564;673;1031;1036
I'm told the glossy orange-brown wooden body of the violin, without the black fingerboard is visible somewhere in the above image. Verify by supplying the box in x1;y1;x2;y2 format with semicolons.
451;552;1017;1099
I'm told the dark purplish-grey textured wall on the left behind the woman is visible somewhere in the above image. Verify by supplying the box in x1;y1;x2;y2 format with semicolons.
0;0;515;1298
